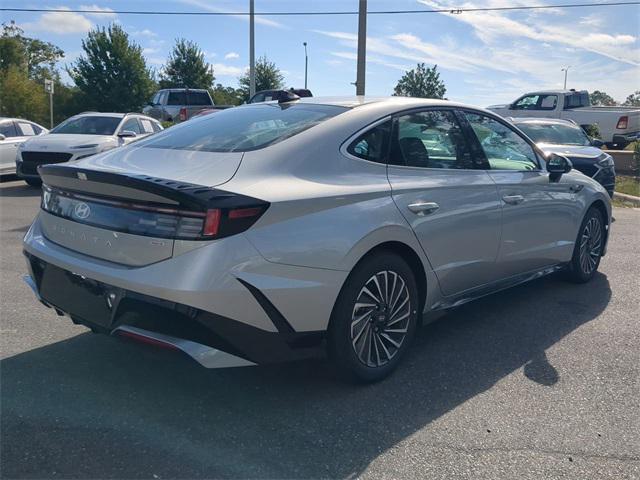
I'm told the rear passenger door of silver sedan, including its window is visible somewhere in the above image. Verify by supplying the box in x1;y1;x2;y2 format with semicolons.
387;109;501;295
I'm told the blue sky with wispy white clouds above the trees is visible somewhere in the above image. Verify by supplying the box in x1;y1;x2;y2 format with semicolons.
5;0;640;106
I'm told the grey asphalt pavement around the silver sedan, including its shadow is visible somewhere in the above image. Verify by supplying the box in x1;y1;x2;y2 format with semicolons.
0;182;640;480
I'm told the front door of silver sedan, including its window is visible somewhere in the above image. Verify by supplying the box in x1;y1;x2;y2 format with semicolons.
464;111;580;277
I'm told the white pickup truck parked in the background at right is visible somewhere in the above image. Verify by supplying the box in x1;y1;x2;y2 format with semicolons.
487;90;640;149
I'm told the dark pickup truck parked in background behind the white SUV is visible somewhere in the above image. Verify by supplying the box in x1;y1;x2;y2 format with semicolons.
142;88;227;123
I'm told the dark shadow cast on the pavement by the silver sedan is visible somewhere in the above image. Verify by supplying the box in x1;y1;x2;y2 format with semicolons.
1;274;611;478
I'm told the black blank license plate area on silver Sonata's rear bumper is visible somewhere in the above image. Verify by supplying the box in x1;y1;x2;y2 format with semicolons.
40;264;122;328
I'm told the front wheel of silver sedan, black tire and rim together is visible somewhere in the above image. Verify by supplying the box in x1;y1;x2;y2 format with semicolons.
568;207;606;283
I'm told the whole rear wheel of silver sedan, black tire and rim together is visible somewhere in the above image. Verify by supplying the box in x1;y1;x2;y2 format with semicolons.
327;251;420;383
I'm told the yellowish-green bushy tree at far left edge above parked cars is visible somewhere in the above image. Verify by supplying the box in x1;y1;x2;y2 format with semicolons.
0;65;49;126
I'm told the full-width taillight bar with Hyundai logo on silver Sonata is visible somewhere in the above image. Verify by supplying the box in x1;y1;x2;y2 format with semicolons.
41;185;269;240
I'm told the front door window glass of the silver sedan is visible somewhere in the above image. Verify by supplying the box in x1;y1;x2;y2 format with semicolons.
465;112;538;170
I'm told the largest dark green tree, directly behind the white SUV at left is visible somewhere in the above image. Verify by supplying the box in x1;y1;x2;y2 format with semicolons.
67;25;155;112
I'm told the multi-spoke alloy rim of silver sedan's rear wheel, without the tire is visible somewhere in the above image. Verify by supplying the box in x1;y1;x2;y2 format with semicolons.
351;270;412;367
